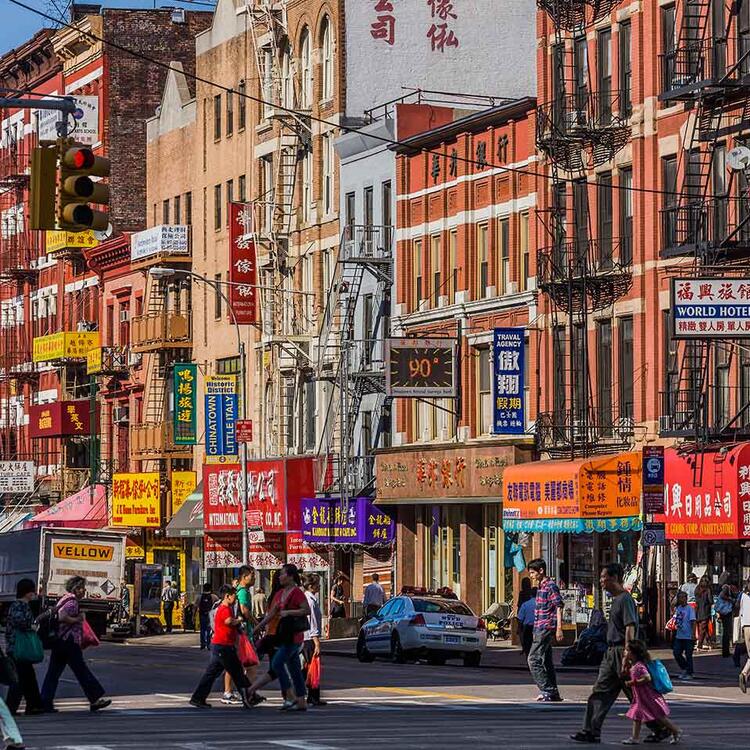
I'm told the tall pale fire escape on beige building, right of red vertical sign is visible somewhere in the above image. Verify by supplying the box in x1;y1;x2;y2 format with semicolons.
247;0;313;456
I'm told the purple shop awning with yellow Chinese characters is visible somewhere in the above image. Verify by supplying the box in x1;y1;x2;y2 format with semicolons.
302;497;394;544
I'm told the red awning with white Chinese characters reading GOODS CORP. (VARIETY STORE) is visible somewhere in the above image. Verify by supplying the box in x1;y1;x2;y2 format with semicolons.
655;443;750;540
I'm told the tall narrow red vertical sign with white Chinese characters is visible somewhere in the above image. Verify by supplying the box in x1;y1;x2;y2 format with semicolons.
229;203;258;325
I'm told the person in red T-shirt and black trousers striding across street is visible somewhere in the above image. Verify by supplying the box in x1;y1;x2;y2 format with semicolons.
190;584;251;708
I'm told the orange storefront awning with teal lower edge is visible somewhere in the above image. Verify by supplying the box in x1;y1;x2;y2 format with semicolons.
503;453;642;533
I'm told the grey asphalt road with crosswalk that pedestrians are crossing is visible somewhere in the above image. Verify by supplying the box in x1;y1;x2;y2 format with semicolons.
10;641;750;750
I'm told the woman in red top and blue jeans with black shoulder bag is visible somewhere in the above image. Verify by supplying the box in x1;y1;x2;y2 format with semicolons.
250;564;310;711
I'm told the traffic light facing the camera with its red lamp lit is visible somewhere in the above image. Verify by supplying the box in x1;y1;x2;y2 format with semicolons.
57;138;110;231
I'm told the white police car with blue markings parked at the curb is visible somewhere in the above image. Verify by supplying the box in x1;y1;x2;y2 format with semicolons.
357;595;487;667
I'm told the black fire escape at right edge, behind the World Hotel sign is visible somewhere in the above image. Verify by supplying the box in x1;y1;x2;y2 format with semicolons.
659;0;750;448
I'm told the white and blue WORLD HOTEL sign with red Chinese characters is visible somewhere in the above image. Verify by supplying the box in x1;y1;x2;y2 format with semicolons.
672;278;750;339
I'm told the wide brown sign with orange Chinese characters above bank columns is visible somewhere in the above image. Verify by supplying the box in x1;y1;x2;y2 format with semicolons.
375;445;518;502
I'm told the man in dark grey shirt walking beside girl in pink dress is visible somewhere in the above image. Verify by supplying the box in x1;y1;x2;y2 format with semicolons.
570;563;669;744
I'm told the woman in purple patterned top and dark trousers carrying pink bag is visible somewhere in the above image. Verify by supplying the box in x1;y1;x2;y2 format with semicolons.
42;576;112;713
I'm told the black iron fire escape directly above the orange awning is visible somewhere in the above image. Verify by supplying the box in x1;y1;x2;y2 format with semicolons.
536;0;634;458
